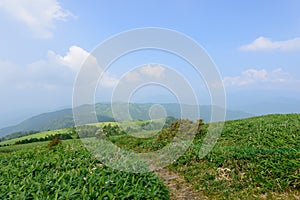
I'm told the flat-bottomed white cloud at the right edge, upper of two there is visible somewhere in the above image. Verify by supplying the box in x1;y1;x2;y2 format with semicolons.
240;37;300;51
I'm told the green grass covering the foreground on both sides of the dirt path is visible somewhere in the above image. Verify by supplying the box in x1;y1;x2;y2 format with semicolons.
0;114;300;199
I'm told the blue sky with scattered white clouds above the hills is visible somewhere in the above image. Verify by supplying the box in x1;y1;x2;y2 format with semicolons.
0;0;300;127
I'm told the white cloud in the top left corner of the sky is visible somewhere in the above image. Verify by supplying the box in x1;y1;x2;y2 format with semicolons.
0;0;72;38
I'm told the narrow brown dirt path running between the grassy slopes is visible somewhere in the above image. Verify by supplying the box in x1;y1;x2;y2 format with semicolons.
155;169;208;200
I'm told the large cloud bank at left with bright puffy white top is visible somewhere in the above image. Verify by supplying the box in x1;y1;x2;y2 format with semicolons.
0;46;118;90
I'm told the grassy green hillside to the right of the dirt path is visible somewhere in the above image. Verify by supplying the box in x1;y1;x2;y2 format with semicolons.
170;114;300;199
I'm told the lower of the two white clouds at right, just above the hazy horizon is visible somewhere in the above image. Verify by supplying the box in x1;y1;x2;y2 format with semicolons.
223;68;297;86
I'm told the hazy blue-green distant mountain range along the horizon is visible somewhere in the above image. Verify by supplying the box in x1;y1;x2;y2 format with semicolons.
0;103;253;137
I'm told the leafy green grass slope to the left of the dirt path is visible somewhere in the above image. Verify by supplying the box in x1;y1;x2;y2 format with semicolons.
0;140;168;199
